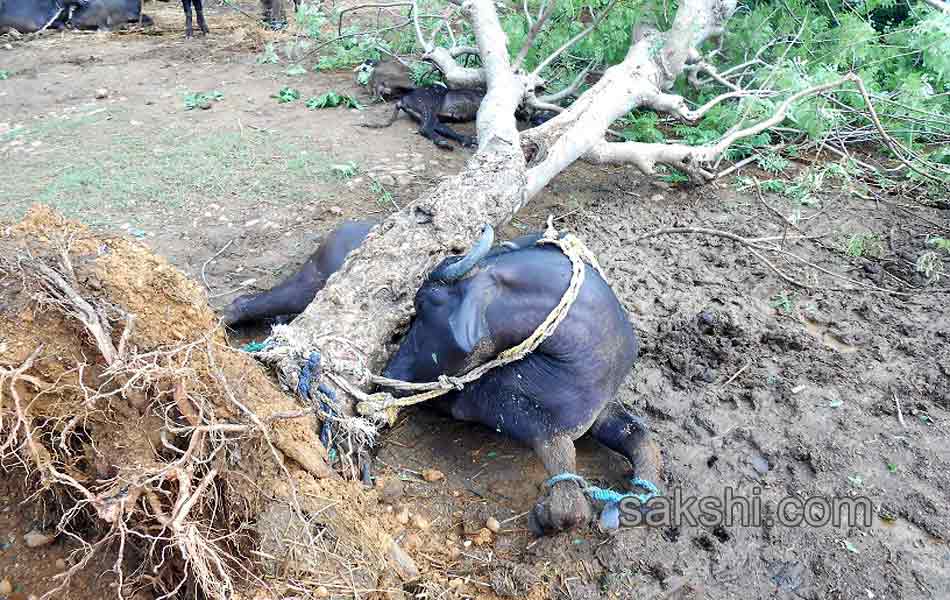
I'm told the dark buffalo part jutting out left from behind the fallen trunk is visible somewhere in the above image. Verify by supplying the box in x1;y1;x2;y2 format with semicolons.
223;221;375;325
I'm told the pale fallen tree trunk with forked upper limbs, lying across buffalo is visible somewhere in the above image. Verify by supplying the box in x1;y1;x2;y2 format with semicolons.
271;0;735;475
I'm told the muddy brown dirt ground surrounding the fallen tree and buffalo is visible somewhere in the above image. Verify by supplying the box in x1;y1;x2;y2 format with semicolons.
0;4;950;600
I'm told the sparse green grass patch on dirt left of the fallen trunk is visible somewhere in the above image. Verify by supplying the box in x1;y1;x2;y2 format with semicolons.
0;113;338;226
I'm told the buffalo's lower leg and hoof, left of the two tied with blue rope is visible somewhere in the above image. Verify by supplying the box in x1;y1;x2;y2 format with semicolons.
528;434;592;535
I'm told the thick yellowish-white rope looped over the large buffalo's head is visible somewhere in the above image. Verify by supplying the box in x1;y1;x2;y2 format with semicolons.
356;217;607;425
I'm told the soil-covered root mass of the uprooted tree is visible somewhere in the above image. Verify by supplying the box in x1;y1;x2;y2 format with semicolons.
0;207;424;599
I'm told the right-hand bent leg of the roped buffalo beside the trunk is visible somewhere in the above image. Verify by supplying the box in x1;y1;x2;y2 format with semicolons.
590;402;660;492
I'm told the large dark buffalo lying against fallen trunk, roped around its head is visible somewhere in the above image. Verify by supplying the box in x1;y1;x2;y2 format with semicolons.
385;228;658;534
